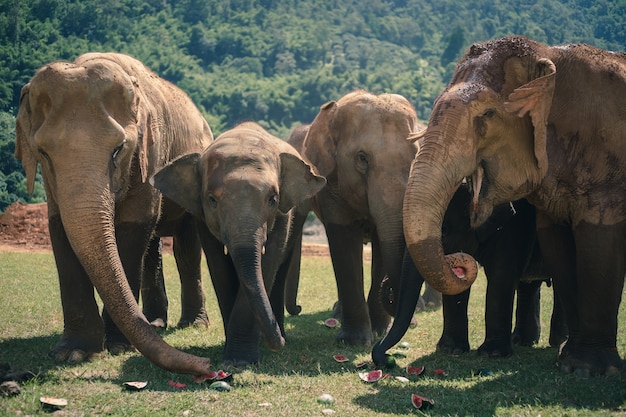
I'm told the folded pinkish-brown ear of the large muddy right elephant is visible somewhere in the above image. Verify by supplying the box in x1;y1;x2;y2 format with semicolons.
504;58;556;178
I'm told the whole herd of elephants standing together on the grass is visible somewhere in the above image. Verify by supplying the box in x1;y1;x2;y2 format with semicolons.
15;37;626;375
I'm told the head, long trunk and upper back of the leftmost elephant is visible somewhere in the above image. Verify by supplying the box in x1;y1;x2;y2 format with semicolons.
15;53;212;374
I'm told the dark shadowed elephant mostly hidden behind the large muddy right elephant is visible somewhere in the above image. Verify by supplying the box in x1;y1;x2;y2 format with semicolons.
372;183;567;365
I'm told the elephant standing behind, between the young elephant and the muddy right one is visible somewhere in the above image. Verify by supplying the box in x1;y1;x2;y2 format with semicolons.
303;91;424;344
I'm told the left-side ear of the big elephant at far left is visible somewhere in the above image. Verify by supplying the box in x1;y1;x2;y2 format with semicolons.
15;83;37;194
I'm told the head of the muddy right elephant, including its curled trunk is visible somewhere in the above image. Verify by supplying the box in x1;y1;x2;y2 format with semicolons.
404;38;555;294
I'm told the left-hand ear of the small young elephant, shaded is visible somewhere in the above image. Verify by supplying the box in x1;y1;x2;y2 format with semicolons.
150;153;203;218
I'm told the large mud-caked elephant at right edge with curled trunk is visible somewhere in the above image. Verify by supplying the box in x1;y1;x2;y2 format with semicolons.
404;37;626;374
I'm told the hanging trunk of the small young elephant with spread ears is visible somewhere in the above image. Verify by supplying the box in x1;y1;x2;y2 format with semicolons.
228;244;285;352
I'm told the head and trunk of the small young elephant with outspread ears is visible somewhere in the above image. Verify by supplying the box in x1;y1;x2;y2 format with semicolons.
152;123;326;360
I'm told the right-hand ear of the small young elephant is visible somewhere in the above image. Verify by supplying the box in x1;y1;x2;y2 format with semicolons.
278;152;326;213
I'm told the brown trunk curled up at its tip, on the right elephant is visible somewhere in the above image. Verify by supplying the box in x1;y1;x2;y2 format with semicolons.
403;120;478;295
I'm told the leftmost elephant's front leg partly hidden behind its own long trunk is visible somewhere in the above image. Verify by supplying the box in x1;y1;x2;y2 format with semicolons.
102;223;152;355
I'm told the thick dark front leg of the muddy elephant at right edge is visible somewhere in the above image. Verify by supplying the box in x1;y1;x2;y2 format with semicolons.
539;222;626;375
